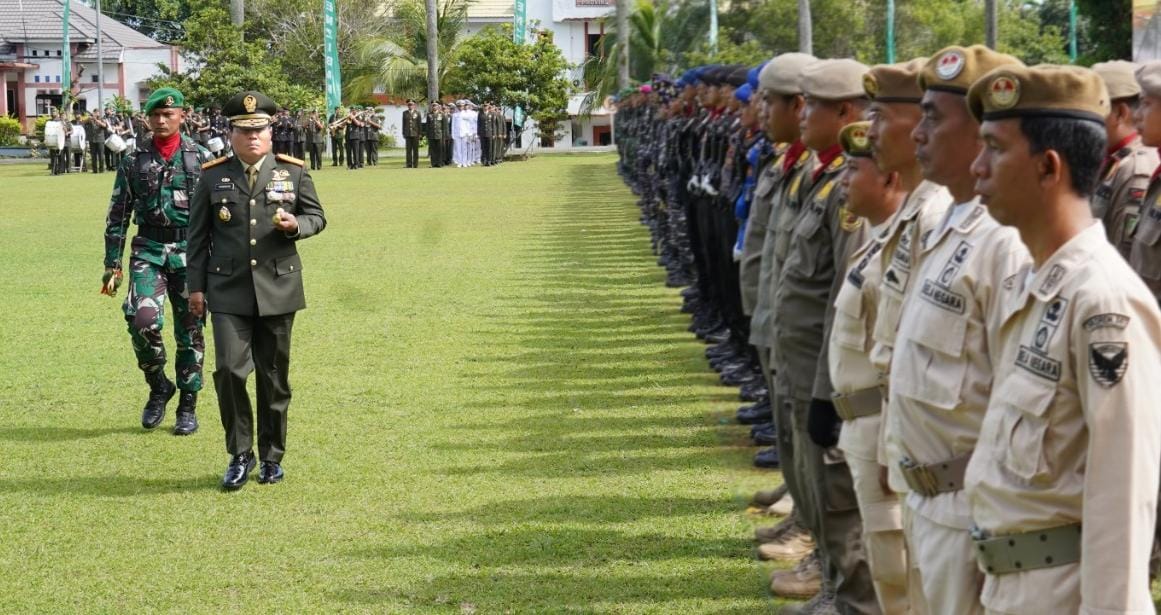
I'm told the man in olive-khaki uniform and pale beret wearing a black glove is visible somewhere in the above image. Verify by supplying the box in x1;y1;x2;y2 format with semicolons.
771;59;878;613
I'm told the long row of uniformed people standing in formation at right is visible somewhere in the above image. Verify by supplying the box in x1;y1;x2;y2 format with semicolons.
615;45;1161;614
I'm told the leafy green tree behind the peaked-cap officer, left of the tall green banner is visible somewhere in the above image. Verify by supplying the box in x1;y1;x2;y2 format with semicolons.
149;0;323;107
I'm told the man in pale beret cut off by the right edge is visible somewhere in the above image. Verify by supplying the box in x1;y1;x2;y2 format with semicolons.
1128;60;1161;303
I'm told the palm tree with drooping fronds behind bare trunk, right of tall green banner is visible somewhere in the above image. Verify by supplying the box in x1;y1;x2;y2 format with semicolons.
344;0;471;100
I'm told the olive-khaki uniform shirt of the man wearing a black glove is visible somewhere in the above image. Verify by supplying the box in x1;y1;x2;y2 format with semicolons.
772;155;864;401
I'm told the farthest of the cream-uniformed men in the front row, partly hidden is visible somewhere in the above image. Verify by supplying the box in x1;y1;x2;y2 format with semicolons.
828;120;917;613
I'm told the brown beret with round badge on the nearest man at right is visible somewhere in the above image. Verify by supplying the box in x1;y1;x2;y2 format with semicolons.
967;64;1109;124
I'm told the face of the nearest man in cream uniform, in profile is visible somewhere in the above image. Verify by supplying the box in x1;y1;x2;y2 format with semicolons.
972;118;1045;227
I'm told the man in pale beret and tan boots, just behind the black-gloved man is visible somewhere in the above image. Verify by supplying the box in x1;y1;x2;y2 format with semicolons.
743;53;822;568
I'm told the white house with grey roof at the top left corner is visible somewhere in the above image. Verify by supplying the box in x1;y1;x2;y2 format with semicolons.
0;0;185;131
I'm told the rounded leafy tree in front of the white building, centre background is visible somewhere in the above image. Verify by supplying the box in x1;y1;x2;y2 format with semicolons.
445;24;570;135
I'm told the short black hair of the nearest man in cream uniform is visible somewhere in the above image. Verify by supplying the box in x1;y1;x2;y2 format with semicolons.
1019;117;1109;198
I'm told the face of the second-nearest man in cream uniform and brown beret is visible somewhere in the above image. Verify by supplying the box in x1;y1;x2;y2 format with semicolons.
911;89;980;186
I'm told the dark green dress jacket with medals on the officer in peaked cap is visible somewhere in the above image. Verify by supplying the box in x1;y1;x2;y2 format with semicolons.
188;154;326;316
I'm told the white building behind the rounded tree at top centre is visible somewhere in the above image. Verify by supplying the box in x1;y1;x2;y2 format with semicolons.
467;0;616;149
